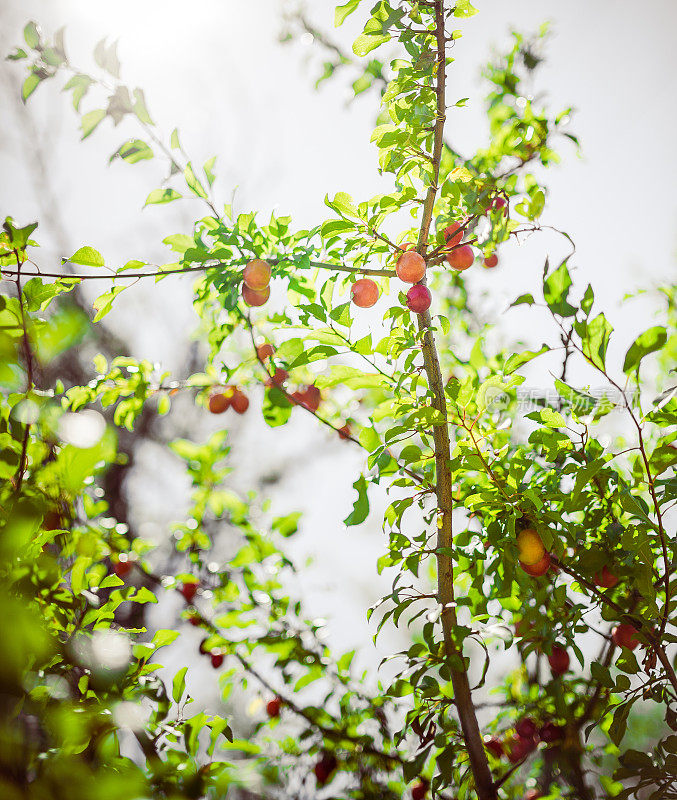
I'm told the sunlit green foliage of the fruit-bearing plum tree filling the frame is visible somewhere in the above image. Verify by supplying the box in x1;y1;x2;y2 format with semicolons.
0;0;677;800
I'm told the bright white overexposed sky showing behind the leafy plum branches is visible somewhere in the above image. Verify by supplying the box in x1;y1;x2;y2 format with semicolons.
0;0;677;716
